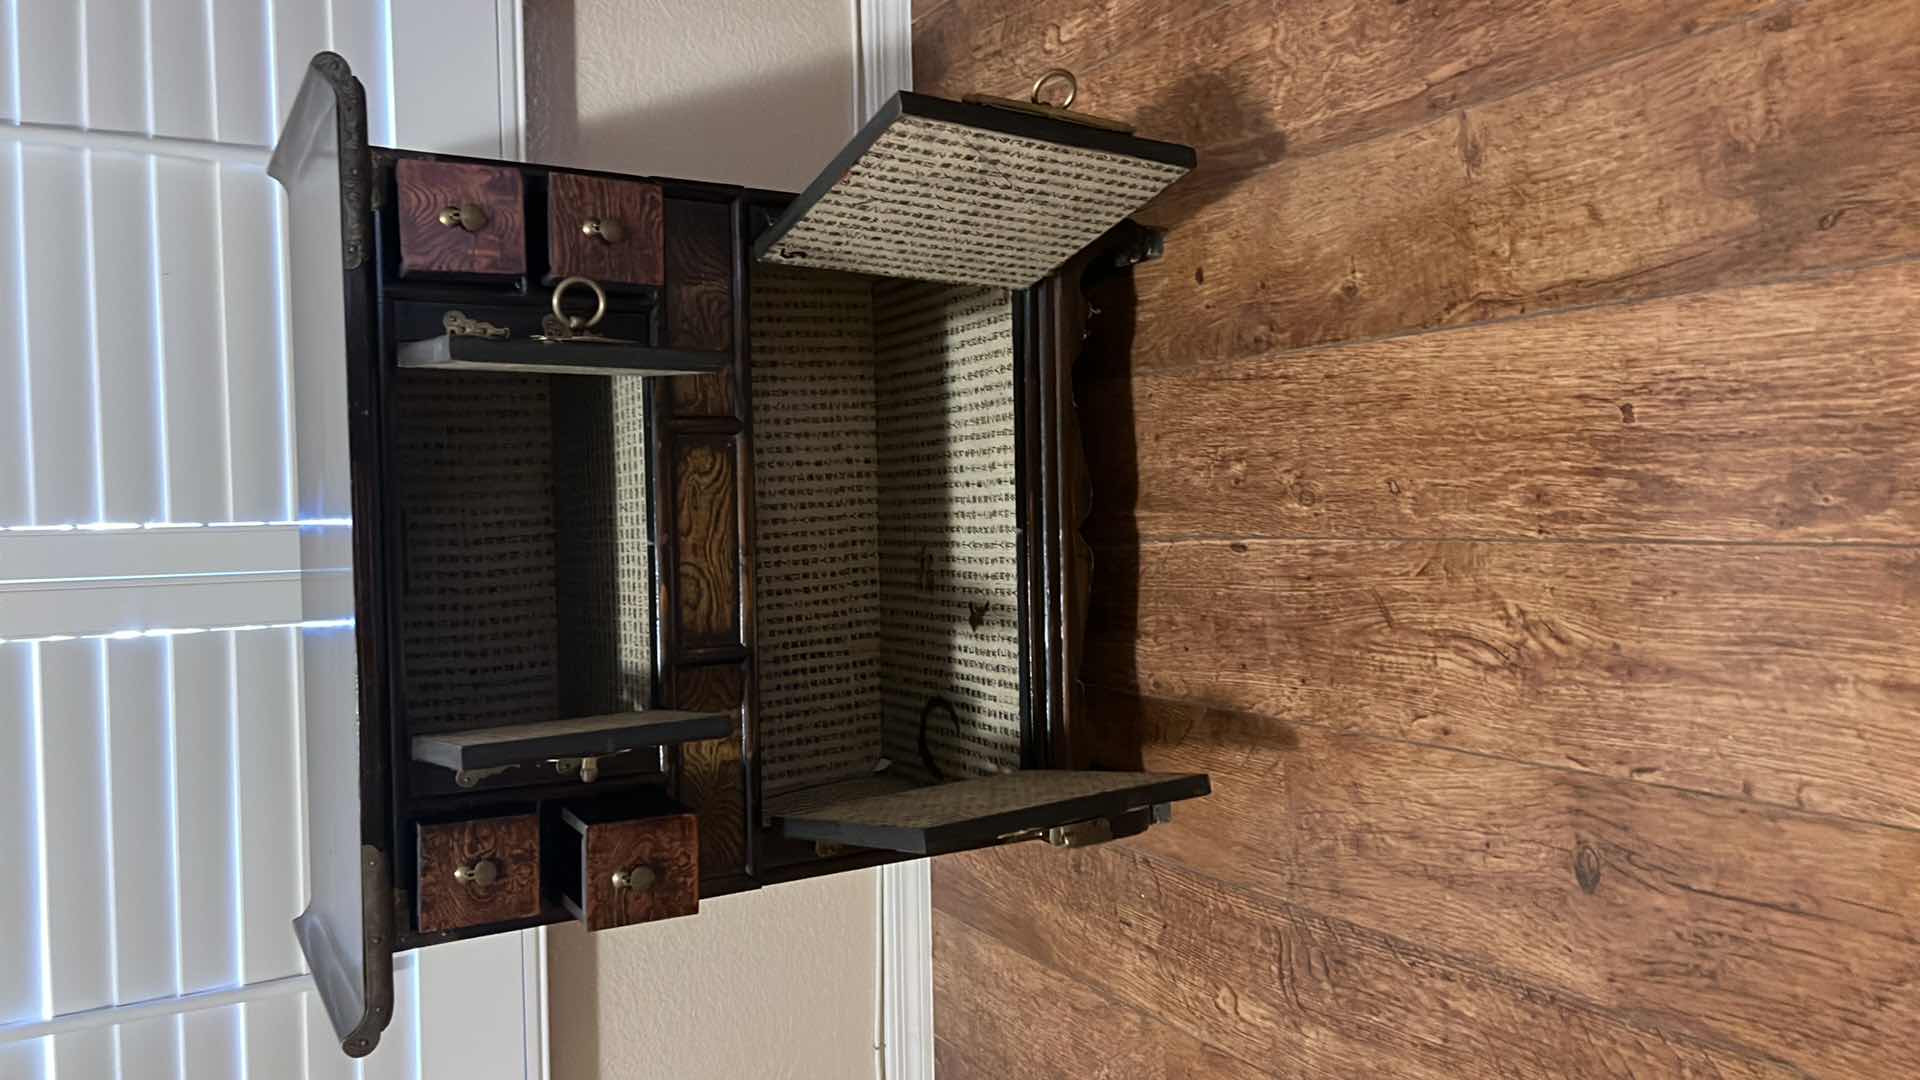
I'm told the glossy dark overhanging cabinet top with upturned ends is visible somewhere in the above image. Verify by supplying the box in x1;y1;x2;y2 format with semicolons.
267;52;394;1057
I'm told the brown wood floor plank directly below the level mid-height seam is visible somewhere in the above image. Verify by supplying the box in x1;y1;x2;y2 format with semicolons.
1087;540;1920;828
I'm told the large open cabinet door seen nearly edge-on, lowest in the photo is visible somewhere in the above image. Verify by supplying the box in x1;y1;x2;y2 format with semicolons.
780;769;1212;855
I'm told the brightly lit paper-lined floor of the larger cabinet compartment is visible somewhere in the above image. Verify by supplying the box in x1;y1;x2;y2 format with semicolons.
874;282;1021;780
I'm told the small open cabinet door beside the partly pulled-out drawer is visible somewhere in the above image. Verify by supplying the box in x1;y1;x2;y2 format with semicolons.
413;709;733;773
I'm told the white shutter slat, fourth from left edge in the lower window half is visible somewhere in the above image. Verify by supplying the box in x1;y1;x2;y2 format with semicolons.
173;632;240;991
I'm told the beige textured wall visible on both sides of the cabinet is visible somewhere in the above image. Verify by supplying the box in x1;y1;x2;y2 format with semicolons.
526;0;879;1080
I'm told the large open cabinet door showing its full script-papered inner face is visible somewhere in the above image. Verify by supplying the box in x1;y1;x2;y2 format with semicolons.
753;90;1194;288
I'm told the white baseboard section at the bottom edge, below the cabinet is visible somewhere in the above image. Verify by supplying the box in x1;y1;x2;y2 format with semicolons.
879;859;933;1080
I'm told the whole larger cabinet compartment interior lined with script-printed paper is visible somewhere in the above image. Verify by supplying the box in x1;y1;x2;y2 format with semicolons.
751;265;1023;815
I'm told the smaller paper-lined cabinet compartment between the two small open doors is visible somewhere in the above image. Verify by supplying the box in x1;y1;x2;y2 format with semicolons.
390;369;659;769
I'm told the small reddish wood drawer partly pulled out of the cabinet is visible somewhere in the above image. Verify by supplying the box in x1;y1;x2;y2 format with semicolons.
557;803;701;930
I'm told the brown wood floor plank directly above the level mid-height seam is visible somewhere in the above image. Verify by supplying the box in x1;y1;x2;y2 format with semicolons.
1083;257;1920;542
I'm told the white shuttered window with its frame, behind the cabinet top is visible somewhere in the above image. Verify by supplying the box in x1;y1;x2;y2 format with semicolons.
0;0;543;1080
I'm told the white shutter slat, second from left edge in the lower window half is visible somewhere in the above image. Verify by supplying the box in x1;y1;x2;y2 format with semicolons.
35;642;113;1015
